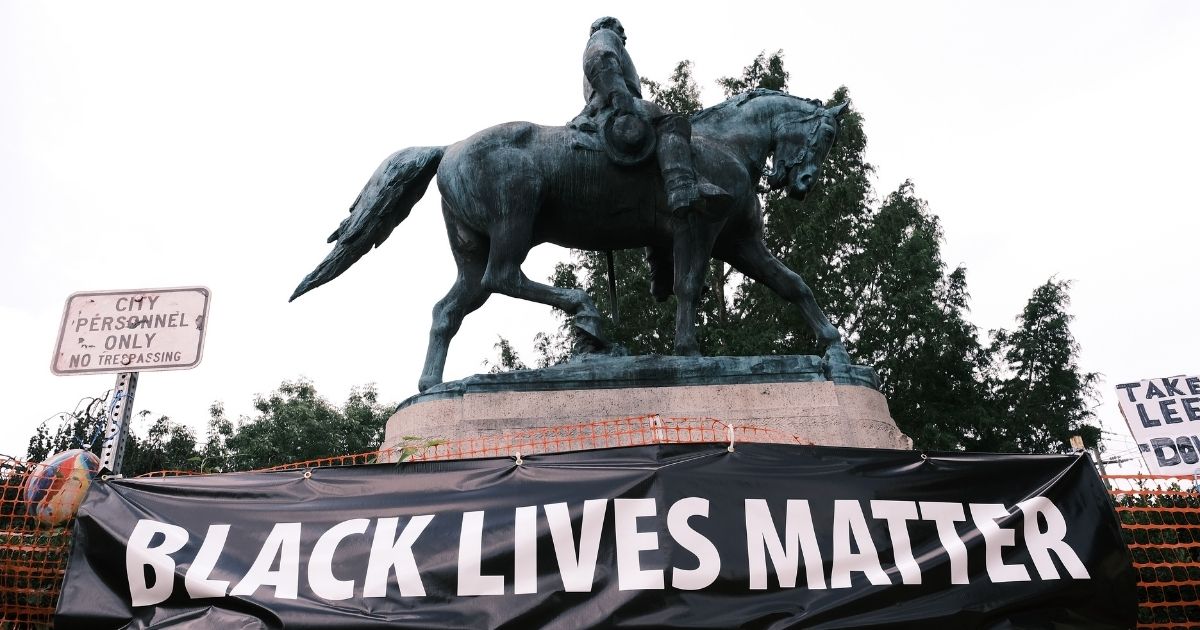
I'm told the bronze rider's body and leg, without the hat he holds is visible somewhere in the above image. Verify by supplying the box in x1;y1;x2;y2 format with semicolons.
582;17;733;216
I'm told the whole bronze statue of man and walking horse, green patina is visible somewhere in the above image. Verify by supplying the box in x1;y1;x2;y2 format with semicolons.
292;18;849;391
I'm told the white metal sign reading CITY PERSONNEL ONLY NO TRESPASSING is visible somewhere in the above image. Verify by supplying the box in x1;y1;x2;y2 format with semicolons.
50;287;210;376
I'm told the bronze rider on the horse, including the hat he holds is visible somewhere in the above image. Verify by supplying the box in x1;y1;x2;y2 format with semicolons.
572;17;733;216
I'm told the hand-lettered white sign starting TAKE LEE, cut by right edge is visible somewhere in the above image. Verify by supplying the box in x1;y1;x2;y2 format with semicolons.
1117;377;1200;475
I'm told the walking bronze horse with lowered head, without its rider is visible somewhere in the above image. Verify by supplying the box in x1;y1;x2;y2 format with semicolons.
289;89;848;391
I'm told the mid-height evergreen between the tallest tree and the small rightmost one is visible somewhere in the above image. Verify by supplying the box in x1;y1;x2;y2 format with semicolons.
839;182;991;449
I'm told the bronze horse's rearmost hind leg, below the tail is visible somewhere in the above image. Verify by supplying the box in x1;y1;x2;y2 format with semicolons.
416;211;490;391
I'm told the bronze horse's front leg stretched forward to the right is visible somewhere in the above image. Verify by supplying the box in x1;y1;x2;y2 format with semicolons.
716;239;848;360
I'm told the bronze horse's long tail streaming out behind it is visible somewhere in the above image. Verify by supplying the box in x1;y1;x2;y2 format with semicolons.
288;146;445;301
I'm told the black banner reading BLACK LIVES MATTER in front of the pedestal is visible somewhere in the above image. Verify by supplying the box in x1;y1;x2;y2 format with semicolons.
55;444;1136;630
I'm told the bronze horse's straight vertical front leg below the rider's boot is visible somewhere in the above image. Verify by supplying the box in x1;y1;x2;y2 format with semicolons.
672;215;716;356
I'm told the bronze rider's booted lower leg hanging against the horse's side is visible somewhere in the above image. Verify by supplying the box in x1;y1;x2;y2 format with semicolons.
658;114;733;217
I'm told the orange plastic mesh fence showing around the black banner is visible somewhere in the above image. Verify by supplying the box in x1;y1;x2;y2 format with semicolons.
0;416;1200;630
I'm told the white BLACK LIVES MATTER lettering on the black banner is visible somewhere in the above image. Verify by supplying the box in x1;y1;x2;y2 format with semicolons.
125;497;1091;606
